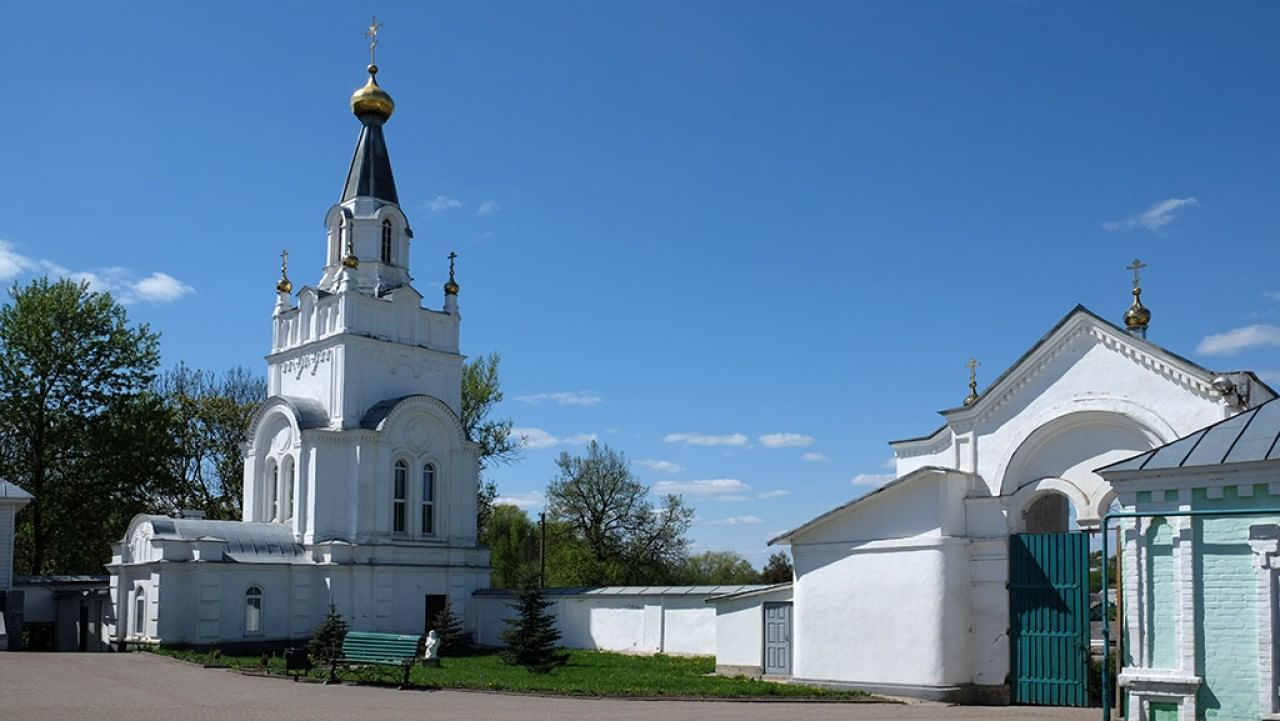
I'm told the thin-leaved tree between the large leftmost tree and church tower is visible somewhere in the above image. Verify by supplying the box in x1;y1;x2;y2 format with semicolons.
155;362;266;520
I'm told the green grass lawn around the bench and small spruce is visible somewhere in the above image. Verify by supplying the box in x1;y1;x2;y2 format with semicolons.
147;648;882;702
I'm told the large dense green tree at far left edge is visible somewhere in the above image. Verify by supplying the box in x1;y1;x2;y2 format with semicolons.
0;278;173;574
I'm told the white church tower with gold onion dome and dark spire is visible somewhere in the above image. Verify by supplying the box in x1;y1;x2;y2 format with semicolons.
108;55;489;645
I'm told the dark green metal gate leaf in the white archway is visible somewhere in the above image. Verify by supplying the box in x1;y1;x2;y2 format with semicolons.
1009;533;1089;706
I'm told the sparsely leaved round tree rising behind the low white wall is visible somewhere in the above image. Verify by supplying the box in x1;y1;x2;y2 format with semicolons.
547;441;694;585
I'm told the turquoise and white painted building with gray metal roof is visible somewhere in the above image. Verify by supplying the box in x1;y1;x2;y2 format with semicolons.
1098;401;1280;721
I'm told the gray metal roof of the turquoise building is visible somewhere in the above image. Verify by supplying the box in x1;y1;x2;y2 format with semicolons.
1098;398;1280;474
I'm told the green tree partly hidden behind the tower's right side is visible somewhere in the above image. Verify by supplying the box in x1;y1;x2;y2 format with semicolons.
462;353;520;533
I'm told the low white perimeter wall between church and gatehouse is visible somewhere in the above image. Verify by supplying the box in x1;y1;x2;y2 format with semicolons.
474;594;716;656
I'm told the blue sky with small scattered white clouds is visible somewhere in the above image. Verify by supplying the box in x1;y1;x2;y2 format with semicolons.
0;0;1280;562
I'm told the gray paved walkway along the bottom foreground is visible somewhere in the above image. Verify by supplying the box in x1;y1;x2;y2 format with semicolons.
0;653;1100;721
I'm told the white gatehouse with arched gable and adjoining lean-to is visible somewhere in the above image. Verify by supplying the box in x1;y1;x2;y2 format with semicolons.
762;302;1275;703
